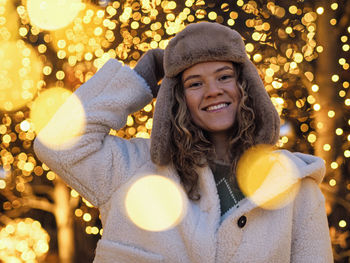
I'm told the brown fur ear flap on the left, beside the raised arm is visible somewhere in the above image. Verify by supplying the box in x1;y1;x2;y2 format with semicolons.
151;77;178;165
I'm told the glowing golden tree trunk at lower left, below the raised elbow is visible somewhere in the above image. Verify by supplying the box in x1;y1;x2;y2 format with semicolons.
54;177;74;263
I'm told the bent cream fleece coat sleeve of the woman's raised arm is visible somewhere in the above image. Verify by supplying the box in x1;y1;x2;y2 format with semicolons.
34;59;152;207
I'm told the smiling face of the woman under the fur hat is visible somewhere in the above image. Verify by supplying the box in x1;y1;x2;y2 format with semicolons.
182;61;240;134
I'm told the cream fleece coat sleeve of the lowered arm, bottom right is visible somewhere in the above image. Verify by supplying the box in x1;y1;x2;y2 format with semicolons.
291;178;333;263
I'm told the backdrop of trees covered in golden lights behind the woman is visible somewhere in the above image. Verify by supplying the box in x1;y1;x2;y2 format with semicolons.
0;0;350;262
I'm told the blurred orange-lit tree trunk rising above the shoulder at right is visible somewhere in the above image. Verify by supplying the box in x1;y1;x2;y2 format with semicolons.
315;0;340;177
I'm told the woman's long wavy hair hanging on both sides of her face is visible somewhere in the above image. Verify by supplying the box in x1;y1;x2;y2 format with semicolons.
170;63;255;200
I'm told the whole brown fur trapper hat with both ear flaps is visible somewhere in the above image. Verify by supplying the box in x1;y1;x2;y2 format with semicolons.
151;22;280;165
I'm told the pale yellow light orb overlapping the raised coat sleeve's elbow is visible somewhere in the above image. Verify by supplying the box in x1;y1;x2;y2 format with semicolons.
30;88;85;149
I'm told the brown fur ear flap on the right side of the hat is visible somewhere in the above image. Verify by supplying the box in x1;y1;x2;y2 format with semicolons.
241;59;280;145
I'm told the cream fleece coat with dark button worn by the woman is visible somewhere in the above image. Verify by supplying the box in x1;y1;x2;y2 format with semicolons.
34;59;333;263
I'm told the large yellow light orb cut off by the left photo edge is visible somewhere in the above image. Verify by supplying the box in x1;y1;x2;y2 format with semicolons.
0;40;42;111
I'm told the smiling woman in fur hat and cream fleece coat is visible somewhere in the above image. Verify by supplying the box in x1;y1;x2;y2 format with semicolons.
34;22;332;263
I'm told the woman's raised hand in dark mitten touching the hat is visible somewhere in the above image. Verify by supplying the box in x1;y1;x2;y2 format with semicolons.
134;48;164;98
